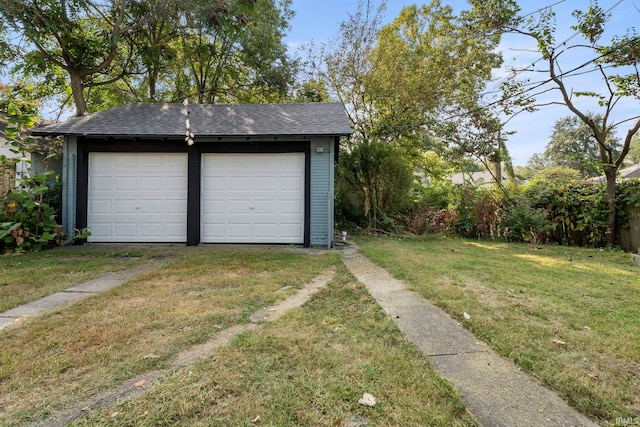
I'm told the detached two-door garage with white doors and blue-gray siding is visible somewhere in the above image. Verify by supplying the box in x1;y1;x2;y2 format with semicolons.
34;103;351;246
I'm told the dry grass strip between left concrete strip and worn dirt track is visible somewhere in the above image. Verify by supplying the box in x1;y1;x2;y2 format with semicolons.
0;251;339;425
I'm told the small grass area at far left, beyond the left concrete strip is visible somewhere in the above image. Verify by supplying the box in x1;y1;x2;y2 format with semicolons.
0;250;152;313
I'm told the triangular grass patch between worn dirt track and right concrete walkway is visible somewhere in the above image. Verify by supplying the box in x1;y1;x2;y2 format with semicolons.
74;268;475;427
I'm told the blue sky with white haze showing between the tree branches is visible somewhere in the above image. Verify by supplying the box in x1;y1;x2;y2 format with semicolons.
286;0;640;166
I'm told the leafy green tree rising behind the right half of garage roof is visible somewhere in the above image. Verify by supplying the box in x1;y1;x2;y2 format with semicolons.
179;0;295;104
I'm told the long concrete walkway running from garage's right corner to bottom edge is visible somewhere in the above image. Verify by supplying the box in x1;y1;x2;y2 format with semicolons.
343;246;597;427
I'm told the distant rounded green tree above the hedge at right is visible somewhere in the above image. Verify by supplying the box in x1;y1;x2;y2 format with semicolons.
544;113;620;177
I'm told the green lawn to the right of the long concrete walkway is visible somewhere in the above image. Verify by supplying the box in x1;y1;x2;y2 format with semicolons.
358;237;640;423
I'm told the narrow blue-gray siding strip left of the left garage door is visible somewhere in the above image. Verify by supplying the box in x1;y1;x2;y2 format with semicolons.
62;136;78;241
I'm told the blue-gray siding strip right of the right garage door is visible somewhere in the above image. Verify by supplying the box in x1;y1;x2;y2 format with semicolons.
310;137;334;246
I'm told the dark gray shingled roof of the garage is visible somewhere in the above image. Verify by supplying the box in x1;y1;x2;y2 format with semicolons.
33;103;351;139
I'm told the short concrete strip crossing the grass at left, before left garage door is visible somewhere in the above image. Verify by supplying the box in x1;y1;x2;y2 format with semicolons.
0;260;161;331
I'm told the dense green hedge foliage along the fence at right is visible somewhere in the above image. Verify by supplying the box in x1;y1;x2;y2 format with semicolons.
368;176;640;252
